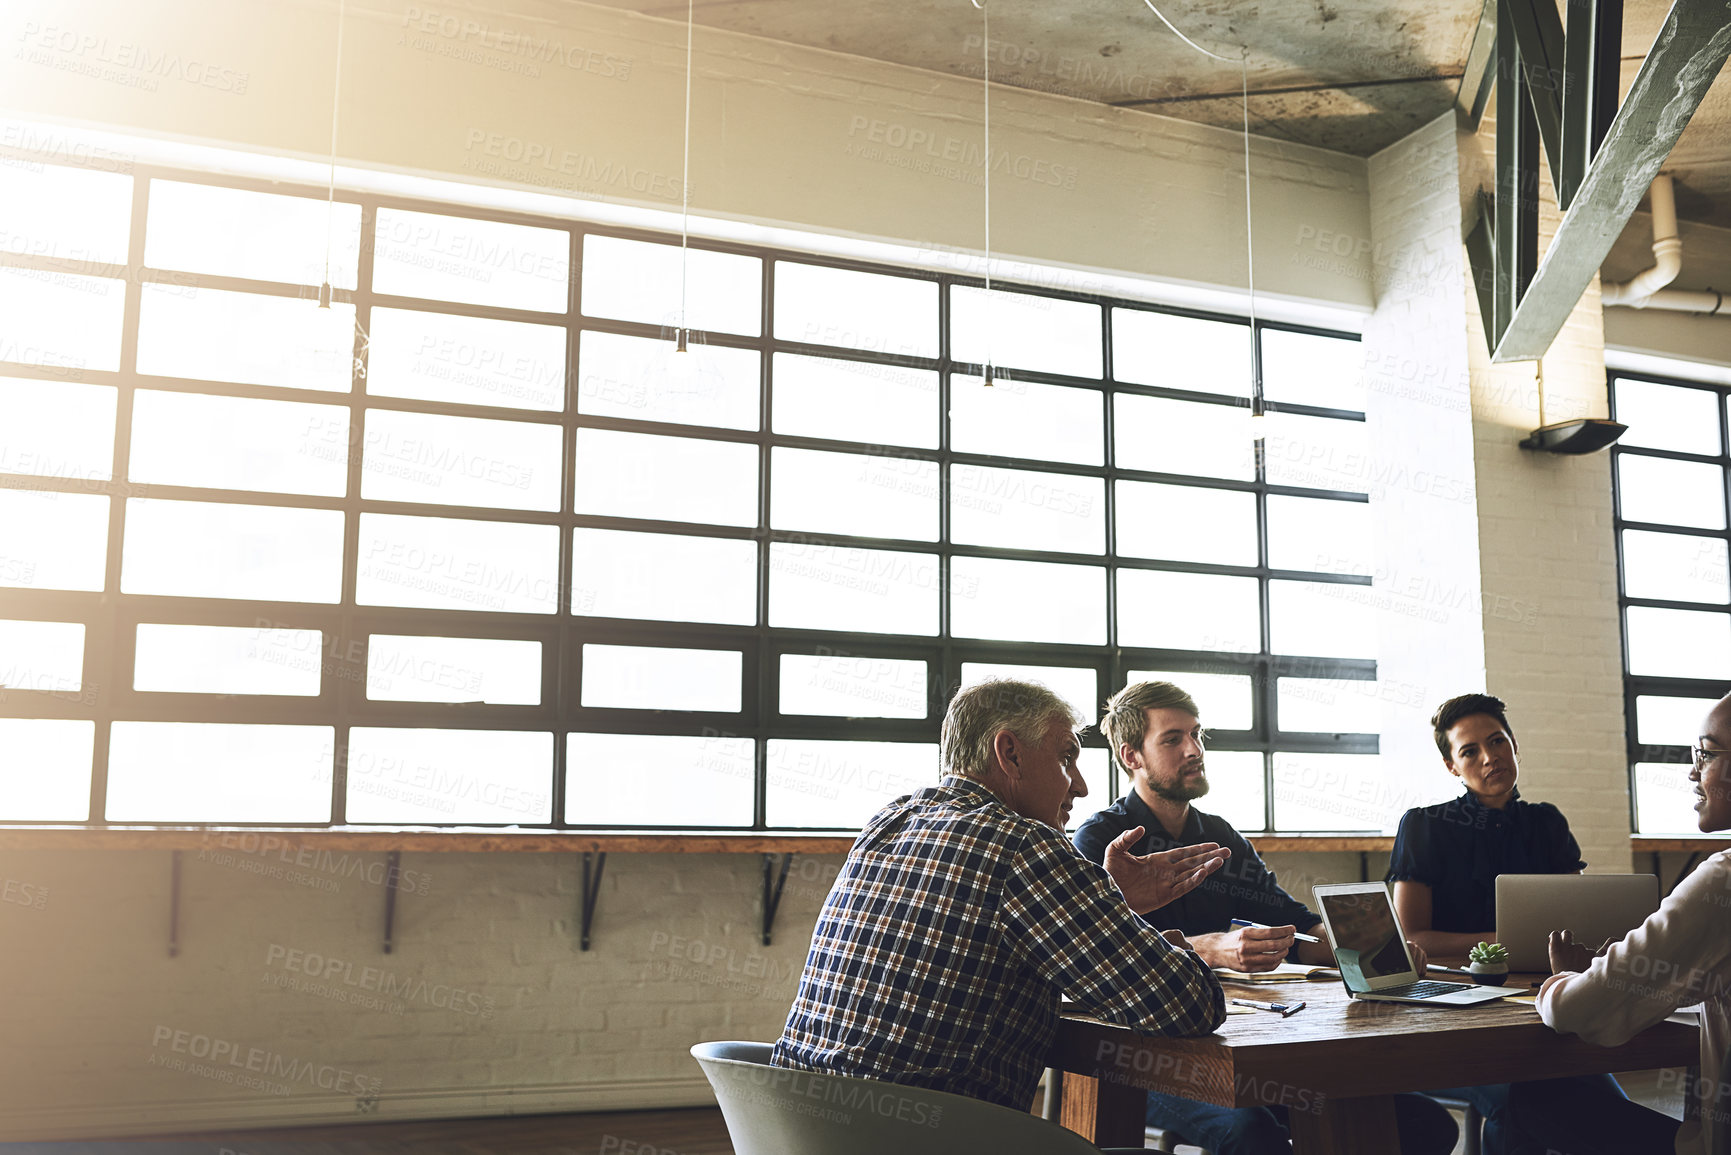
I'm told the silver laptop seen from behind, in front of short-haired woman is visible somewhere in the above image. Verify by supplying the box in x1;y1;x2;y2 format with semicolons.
1497;874;1658;971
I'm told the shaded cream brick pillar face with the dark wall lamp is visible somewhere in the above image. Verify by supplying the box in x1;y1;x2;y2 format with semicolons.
1461;133;1644;873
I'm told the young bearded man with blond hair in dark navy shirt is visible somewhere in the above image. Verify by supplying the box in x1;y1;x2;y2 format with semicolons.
1075;682;1459;1155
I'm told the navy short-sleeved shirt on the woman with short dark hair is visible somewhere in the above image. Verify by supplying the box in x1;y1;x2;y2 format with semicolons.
1387;790;1586;933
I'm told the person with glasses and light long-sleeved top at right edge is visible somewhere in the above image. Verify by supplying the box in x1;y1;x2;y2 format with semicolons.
1544;694;1731;1155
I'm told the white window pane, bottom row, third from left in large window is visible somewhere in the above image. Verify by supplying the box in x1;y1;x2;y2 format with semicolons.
348;726;552;824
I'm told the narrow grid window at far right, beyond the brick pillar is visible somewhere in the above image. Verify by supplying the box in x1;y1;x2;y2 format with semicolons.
1610;372;1731;835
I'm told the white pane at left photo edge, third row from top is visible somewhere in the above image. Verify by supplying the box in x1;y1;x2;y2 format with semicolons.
0;380;118;481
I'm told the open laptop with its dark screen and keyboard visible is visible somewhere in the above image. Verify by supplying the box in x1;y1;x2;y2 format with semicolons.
1314;883;1515;1006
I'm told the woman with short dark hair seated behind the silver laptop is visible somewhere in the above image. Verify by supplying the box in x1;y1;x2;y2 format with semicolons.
1387;694;1670;1155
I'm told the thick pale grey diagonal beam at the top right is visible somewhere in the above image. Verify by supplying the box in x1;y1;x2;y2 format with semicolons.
1490;0;1731;362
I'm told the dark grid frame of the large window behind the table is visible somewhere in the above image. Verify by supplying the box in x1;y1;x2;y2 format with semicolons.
0;153;1378;833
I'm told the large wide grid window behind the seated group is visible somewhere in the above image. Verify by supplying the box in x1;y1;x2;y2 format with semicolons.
0;155;1377;831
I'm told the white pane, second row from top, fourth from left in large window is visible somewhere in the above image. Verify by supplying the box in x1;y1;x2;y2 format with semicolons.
576;329;762;429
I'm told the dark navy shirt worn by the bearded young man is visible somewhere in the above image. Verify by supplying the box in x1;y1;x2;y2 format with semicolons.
1075;790;1322;951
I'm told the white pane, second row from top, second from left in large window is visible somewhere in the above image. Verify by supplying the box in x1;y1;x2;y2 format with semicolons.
138;284;355;393
